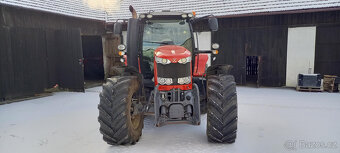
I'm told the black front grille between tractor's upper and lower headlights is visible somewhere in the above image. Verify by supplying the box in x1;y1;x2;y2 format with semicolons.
157;62;191;85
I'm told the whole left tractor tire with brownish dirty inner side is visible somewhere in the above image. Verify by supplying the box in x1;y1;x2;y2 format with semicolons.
98;76;144;145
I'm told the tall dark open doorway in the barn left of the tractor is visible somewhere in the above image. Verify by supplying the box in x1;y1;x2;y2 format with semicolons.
82;36;104;88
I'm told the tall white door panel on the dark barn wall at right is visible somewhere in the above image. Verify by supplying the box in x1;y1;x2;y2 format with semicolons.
286;27;316;87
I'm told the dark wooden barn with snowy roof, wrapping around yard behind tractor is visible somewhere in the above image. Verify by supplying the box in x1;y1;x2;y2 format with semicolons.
0;0;340;101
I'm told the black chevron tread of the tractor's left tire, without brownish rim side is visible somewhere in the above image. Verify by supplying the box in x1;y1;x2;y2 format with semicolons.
98;76;143;145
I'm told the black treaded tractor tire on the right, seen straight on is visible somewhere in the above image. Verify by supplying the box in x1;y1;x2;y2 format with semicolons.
207;74;237;143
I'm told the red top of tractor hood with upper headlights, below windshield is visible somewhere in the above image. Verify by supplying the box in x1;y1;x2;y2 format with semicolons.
155;45;191;63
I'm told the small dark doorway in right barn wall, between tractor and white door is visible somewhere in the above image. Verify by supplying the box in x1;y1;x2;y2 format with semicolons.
246;56;259;86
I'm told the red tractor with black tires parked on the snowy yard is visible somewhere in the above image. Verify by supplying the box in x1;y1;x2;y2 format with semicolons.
98;7;237;145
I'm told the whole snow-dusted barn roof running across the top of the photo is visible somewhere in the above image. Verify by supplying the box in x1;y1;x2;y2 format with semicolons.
0;0;340;22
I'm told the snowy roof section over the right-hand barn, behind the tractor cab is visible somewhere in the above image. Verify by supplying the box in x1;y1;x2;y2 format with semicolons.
108;0;340;21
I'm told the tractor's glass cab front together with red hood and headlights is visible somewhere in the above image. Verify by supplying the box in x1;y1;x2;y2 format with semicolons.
139;12;194;90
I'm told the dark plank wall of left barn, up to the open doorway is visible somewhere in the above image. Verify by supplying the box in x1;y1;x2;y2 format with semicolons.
0;5;105;101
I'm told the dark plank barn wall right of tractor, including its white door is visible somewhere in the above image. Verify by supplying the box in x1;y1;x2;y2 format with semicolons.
212;8;340;87
